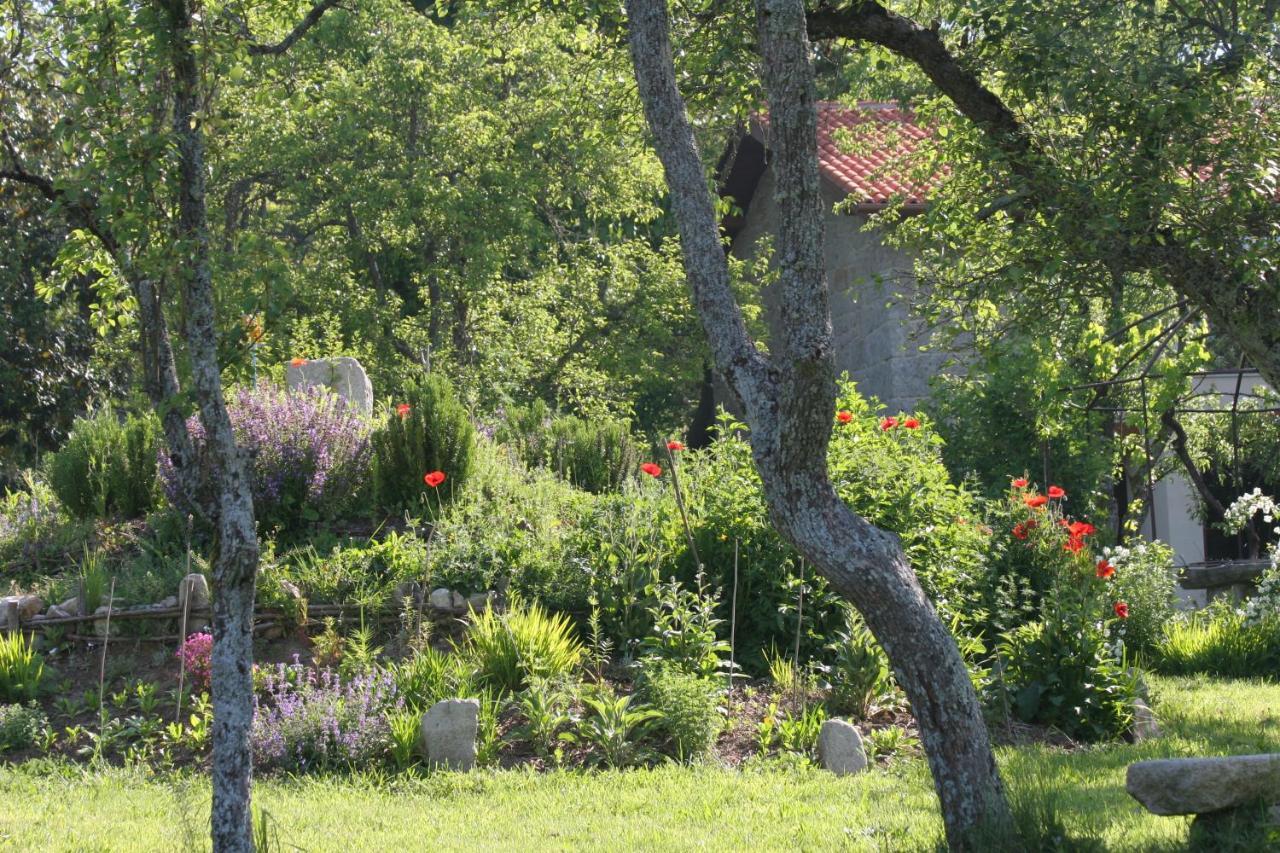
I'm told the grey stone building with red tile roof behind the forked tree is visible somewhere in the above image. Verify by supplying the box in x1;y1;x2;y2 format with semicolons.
721;102;947;411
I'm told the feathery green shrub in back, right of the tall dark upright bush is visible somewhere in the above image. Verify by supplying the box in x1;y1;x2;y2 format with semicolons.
495;401;640;493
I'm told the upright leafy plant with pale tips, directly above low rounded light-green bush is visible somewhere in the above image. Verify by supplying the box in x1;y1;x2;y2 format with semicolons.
640;575;730;678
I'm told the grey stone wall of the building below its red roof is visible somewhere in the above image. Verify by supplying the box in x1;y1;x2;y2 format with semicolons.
732;170;947;411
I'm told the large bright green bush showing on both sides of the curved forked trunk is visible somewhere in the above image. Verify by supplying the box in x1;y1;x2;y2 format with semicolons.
682;389;989;670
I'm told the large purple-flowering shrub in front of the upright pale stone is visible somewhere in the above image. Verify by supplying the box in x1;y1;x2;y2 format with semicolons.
159;384;370;529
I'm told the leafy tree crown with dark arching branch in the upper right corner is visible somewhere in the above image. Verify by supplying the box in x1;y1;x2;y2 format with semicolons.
809;0;1280;386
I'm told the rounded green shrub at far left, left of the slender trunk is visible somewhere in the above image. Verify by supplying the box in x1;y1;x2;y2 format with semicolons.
47;407;160;519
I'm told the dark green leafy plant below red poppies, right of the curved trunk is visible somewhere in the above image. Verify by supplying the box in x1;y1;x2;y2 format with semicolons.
988;620;1138;742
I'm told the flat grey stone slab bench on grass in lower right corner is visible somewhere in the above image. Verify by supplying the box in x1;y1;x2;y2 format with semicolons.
1125;753;1280;815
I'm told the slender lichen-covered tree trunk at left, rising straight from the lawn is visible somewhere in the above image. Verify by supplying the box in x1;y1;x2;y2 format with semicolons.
161;0;257;852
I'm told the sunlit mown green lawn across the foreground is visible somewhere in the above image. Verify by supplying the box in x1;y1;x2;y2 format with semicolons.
0;679;1280;852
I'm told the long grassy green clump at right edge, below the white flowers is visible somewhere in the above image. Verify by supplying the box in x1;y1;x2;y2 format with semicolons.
1152;605;1280;680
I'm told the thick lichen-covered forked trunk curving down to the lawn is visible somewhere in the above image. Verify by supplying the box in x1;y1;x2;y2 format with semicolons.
626;0;1010;849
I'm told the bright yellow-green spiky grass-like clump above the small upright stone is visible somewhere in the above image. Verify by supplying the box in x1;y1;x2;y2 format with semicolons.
463;591;586;690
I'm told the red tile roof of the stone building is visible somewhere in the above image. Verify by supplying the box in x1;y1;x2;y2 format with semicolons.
760;101;932;209
